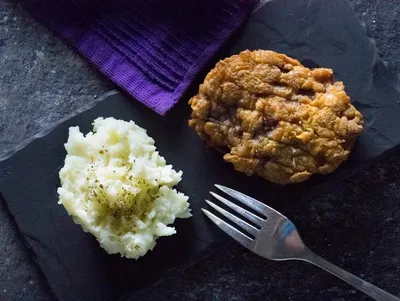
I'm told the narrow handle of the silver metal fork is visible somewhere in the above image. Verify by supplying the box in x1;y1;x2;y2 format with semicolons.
299;251;400;301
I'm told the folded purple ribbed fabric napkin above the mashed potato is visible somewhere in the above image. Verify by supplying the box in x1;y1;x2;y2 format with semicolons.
22;0;254;115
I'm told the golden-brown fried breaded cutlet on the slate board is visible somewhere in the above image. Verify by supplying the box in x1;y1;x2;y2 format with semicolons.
189;50;363;184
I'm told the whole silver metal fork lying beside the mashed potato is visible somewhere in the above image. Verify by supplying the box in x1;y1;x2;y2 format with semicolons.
202;185;400;301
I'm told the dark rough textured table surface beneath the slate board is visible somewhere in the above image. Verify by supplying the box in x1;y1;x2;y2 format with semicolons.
0;0;400;301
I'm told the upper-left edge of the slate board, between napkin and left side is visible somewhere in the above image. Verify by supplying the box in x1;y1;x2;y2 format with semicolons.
0;90;120;163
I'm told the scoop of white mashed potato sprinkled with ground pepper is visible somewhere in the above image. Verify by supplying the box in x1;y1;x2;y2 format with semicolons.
58;117;191;259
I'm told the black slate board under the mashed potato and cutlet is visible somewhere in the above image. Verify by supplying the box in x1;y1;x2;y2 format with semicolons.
0;0;400;301
